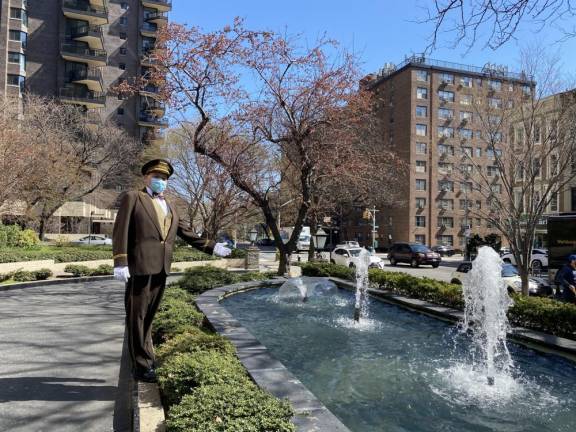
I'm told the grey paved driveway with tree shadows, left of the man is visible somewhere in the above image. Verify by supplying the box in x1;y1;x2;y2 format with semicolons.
0;281;130;432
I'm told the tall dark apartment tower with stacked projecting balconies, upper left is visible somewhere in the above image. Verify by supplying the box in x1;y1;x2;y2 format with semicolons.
0;0;172;236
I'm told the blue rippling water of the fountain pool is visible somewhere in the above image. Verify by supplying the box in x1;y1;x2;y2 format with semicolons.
222;285;576;432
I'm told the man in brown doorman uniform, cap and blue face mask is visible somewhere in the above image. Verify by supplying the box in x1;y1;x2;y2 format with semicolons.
112;159;231;382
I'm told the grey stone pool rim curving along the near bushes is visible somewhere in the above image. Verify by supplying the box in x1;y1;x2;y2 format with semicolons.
196;278;350;432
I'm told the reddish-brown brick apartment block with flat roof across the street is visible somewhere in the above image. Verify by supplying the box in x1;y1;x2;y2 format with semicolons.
342;56;534;248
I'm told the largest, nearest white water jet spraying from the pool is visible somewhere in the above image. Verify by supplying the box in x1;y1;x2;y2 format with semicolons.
462;246;512;385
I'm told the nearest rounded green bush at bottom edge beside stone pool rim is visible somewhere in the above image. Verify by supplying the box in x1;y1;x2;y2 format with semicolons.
167;382;295;432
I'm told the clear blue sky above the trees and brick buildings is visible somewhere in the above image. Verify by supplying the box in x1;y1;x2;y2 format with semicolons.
171;0;576;75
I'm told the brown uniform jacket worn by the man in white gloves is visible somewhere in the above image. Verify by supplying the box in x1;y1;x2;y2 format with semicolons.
112;189;214;276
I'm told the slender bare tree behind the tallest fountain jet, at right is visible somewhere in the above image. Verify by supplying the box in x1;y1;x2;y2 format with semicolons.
459;50;576;295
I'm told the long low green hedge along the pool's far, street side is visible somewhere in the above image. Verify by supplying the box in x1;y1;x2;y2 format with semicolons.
300;263;576;339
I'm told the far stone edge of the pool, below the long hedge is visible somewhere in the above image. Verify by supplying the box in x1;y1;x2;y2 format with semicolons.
329;277;576;362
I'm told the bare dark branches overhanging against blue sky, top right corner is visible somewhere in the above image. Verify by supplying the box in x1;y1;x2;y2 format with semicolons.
424;0;576;51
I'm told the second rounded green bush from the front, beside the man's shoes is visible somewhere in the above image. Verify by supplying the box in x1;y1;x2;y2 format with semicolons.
157;351;249;407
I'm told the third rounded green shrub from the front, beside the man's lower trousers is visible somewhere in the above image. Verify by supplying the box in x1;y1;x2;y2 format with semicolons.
156;327;235;363
